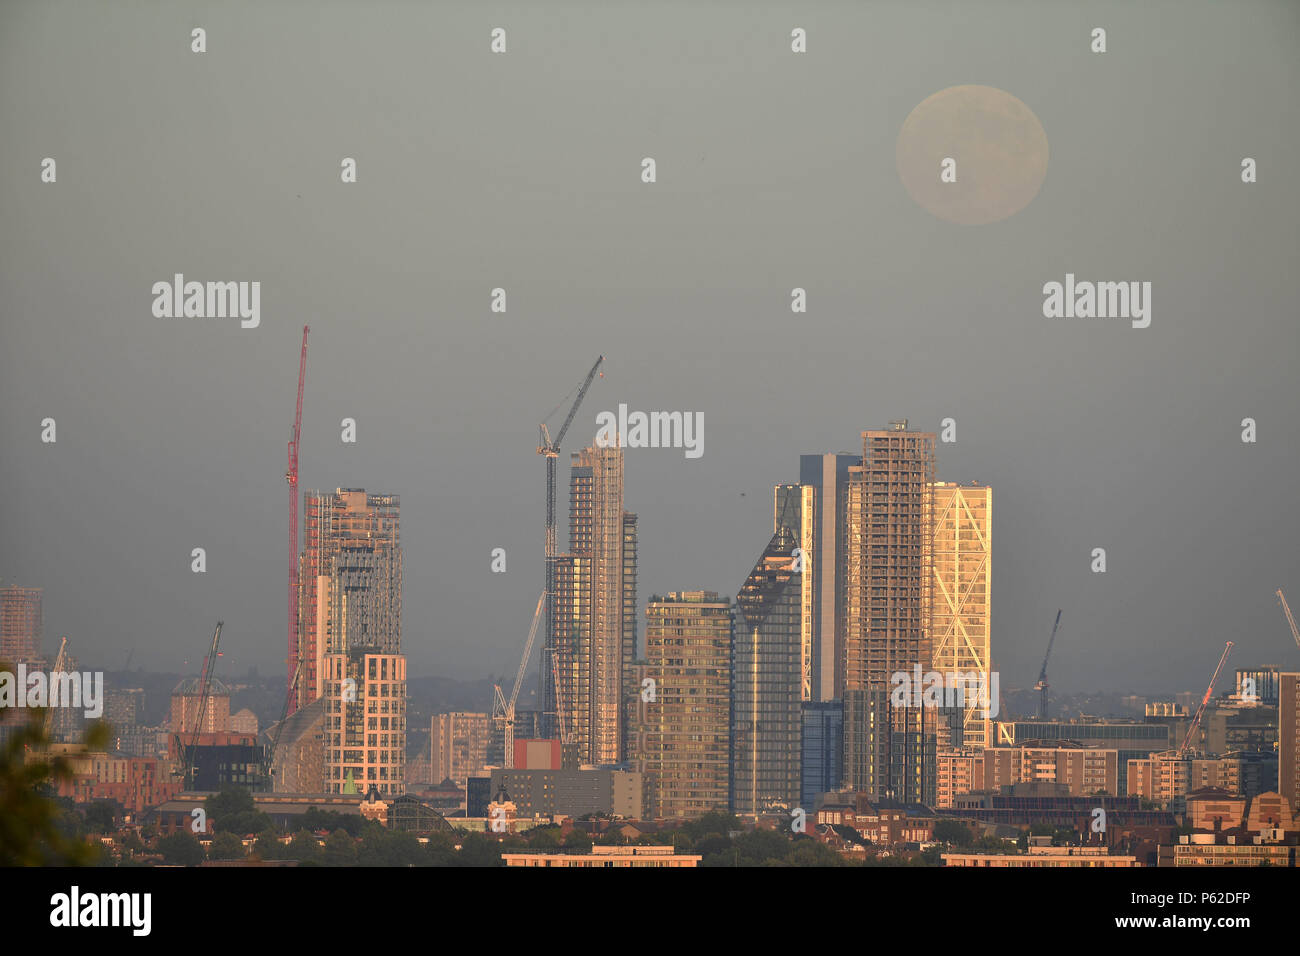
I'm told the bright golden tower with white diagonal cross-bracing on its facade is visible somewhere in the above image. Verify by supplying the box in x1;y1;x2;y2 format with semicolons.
930;481;987;749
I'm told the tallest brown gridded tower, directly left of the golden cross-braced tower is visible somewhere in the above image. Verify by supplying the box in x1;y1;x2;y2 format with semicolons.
844;421;936;805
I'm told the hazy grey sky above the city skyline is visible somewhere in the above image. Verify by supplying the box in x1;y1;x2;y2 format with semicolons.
0;0;1300;691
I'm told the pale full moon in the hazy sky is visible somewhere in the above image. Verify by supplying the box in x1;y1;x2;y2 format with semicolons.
897;86;1048;225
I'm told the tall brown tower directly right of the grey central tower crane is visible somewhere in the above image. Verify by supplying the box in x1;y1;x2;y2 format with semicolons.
542;447;637;765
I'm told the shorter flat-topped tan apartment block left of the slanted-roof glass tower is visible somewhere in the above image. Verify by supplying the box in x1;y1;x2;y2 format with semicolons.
645;591;732;819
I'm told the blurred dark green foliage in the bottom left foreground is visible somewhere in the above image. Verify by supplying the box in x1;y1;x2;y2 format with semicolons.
0;712;108;866
